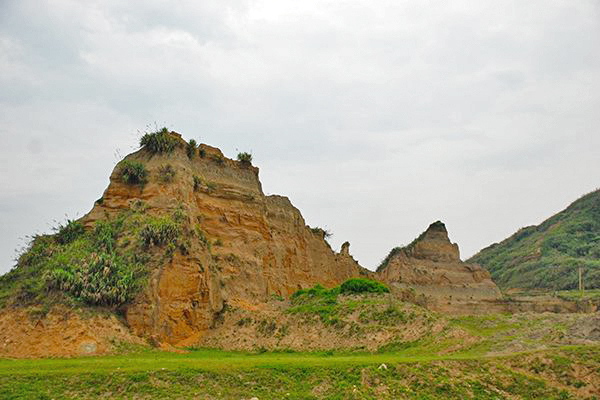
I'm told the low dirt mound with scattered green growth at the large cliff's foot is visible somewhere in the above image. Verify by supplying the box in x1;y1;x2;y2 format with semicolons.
195;295;452;351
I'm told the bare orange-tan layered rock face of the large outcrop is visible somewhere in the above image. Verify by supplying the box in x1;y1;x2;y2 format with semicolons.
83;133;369;344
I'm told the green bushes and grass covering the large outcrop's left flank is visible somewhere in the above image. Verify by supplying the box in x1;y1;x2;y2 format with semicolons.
0;204;187;307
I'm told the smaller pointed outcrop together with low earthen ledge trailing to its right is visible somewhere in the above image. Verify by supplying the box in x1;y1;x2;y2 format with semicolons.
376;221;596;314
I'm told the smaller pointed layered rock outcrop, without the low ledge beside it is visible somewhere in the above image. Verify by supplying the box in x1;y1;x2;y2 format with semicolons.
377;221;502;313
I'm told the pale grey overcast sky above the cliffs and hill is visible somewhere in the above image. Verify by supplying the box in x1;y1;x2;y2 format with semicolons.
0;0;600;272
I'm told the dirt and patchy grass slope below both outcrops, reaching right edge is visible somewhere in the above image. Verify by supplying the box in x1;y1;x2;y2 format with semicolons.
192;294;600;356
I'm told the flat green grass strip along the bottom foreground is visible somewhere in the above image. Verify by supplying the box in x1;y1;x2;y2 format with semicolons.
0;347;600;400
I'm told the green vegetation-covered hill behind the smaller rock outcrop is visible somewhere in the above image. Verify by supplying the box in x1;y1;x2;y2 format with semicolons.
468;190;600;289
